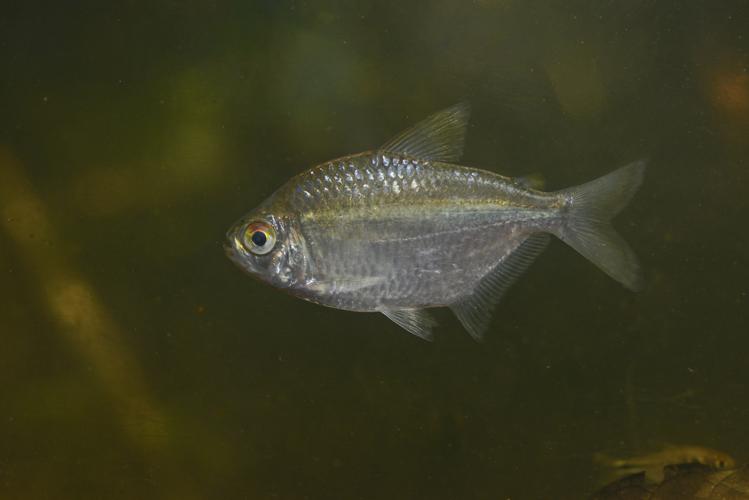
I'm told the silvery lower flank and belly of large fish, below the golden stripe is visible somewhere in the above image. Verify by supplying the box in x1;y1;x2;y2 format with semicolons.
296;206;551;311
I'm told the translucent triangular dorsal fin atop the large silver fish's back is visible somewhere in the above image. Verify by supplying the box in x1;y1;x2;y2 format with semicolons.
381;102;471;162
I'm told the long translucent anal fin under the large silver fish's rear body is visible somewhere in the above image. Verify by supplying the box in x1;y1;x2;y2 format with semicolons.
450;233;550;341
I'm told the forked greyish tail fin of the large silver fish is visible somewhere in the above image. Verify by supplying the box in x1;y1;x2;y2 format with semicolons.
557;161;645;290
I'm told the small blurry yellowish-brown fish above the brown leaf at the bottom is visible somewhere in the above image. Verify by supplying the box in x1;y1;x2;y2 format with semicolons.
594;445;736;483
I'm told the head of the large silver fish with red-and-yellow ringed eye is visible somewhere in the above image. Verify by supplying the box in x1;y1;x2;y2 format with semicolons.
224;209;306;288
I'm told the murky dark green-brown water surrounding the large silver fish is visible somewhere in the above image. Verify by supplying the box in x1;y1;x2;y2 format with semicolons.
0;0;749;499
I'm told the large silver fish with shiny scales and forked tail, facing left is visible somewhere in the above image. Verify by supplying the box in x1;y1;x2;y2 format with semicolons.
224;102;645;341
